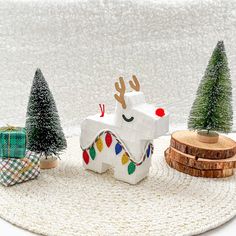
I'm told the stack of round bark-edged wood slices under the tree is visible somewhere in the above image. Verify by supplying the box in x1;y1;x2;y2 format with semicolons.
165;130;236;178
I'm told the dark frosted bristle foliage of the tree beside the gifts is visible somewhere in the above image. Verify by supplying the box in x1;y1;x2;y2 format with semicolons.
26;69;67;158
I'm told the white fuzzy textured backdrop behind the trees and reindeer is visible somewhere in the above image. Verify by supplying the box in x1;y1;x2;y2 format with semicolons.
0;0;236;134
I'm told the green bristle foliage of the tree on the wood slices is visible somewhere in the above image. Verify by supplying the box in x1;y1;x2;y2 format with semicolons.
188;41;233;134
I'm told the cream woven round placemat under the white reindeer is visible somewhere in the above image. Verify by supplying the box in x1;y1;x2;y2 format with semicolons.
0;137;236;236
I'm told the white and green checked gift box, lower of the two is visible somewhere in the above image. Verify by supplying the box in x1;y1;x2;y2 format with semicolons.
0;152;40;186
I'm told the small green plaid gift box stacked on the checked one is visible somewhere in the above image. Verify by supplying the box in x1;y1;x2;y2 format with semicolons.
0;126;26;158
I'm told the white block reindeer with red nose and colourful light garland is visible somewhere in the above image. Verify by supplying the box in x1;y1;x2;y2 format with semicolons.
80;76;169;184
